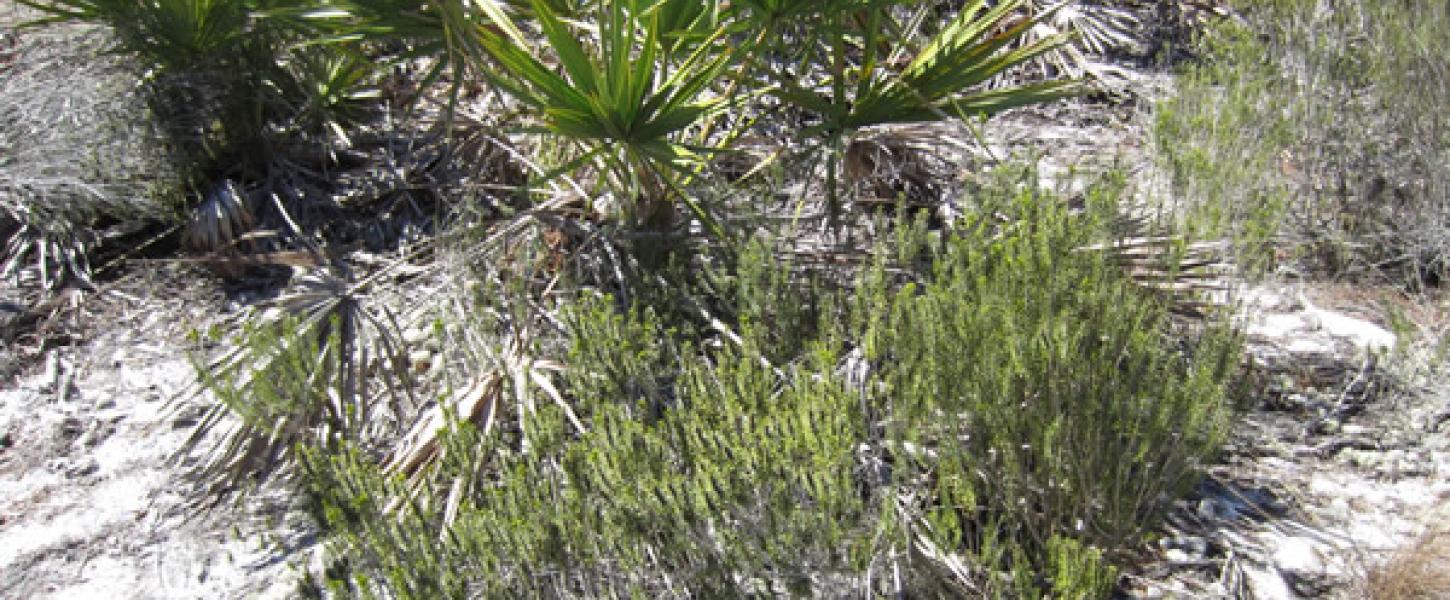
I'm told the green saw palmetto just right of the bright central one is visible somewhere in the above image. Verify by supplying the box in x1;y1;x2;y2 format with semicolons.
766;0;1082;213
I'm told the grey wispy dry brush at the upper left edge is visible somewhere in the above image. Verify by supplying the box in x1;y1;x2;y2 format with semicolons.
0;25;175;290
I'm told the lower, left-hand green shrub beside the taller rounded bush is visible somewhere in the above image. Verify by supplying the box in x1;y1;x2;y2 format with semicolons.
309;297;870;597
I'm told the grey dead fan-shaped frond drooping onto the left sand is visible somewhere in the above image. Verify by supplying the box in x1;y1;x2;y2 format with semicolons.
181;270;416;496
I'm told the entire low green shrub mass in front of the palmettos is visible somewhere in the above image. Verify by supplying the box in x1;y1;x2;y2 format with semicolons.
306;176;1237;599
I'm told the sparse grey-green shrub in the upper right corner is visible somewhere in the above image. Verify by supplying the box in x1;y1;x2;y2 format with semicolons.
1157;0;1450;288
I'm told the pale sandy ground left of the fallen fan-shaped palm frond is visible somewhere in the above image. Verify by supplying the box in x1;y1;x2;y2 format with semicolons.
0;268;313;599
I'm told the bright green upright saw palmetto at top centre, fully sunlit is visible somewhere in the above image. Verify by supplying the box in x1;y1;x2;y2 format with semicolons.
464;1;734;233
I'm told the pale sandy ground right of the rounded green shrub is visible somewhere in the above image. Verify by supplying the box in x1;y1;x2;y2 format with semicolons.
1130;286;1450;600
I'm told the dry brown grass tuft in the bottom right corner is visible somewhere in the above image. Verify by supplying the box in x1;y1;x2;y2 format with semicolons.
1363;523;1450;600
